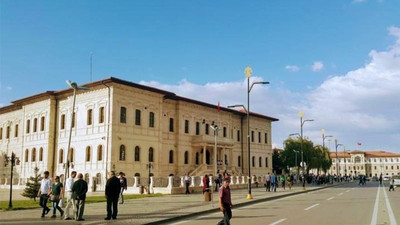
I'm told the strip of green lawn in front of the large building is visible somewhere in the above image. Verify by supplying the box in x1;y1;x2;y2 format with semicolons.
0;194;163;210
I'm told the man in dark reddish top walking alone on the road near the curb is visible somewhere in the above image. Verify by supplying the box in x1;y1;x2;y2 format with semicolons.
218;178;233;225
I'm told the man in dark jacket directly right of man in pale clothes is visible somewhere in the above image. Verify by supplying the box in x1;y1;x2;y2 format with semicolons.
72;173;88;221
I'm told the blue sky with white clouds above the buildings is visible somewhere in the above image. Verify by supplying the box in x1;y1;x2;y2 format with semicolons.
0;0;400;153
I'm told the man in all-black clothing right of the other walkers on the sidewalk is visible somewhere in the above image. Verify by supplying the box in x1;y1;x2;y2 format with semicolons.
104;171;121;220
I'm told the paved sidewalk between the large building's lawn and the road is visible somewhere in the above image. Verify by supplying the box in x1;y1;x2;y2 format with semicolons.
0;185;340;224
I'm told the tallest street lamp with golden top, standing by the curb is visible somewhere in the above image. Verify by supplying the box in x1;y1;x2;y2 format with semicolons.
228;67;269;199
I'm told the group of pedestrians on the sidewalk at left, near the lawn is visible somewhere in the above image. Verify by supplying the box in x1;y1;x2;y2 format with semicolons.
37;171;127;221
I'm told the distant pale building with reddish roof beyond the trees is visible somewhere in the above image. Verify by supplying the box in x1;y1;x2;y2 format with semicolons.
329;150;400;177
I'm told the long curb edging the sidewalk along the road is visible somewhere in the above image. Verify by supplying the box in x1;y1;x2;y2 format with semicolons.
145;183;346;225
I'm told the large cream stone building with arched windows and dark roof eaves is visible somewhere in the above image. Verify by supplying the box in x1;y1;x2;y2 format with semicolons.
0;78;278;190
